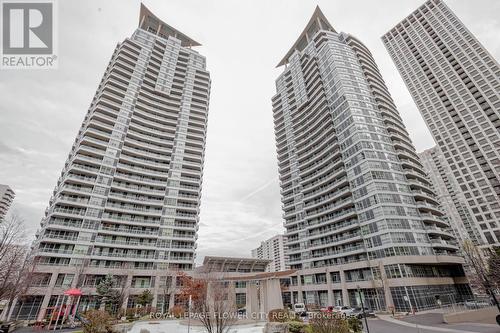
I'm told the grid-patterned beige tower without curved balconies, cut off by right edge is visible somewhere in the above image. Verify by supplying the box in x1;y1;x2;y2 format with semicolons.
382;0;500;249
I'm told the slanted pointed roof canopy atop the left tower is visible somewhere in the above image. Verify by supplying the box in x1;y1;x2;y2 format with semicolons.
139;3;201;46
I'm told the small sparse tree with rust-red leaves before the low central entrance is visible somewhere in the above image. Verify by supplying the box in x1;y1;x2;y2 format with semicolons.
179;274;237;333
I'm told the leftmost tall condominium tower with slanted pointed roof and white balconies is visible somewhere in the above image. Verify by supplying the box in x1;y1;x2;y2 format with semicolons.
21;5;210;317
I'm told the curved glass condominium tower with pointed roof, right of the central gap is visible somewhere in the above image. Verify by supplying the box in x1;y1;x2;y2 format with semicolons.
272;8;470;309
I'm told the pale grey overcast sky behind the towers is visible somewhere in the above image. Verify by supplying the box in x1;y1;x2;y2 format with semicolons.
0;0;500;262
